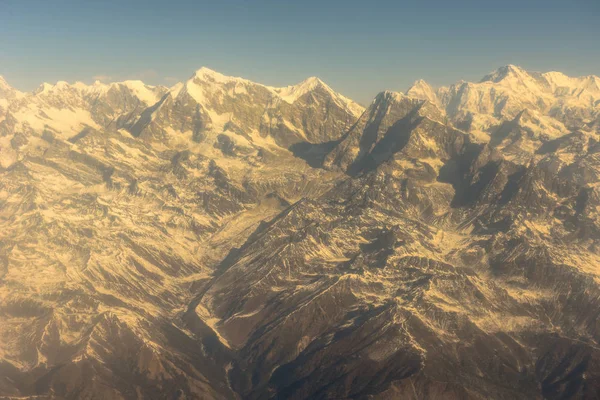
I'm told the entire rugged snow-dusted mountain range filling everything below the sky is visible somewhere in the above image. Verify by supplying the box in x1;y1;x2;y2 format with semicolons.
0;66;600;399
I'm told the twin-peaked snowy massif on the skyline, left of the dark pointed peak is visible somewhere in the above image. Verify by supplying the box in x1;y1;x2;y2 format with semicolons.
126;68;363;147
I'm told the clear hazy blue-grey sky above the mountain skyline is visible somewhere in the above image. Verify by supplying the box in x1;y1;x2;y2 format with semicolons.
0;0;600;104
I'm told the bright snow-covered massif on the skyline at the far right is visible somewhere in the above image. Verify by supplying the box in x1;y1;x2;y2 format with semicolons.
407;65;600;152
